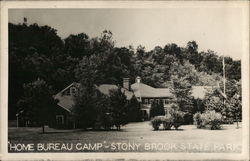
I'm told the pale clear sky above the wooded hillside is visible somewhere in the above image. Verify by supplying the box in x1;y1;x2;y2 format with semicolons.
9;8;243;60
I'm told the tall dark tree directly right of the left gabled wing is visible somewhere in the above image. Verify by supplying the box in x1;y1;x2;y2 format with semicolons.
74;55;104;129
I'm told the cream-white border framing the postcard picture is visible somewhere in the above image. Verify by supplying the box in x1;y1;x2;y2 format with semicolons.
0;1;249;160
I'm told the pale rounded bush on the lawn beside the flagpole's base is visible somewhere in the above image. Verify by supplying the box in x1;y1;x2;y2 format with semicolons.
194;111;222;130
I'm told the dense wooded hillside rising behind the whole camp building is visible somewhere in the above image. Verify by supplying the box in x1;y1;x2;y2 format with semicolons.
8;20;241;124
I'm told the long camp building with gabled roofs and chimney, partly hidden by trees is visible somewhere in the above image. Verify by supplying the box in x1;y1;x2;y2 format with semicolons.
54;77;212;127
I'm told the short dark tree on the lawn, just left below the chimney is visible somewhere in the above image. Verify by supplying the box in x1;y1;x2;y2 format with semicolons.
109;87;128;130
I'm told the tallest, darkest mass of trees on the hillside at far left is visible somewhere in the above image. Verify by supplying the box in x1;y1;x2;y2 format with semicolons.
8;23;64;119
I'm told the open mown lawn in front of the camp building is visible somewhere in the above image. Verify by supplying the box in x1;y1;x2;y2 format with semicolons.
8;122;242;153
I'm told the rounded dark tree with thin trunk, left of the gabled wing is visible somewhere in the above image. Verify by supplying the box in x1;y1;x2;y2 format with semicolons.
18;78;57;133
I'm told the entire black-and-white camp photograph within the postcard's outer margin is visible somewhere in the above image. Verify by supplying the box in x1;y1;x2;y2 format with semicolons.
1;2;249;159
